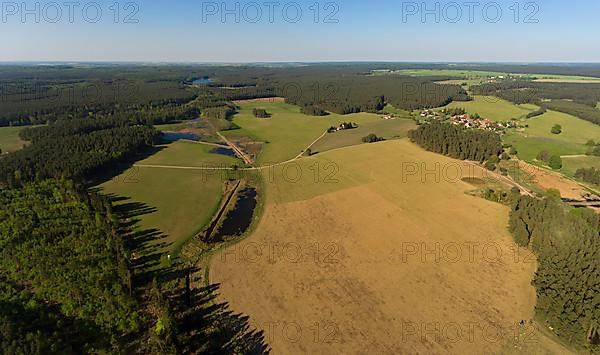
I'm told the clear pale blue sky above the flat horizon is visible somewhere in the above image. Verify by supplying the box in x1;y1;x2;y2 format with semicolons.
0;0;600;63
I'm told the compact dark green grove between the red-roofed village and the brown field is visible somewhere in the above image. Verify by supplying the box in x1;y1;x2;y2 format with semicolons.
409;122;503;162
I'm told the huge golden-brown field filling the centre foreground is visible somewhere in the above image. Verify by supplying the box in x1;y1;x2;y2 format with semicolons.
210;140;536;354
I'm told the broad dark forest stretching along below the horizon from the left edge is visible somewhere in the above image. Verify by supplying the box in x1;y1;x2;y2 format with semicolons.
0;64;470;126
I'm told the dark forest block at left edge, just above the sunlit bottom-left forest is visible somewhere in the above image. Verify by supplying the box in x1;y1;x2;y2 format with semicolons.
0;118;161;186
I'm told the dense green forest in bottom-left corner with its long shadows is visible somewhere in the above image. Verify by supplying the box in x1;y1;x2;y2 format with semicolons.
0;179;268;355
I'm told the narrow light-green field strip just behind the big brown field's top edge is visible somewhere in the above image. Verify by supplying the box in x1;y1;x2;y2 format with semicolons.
312;119;417;153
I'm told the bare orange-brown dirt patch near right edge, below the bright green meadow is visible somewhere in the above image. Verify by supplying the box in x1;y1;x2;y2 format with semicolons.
519;161;589;200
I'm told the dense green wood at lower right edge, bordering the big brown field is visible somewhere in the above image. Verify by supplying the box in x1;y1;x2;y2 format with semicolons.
509;196;600;350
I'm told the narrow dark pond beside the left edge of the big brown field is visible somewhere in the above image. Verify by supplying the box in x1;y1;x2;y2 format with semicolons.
214;188;257;240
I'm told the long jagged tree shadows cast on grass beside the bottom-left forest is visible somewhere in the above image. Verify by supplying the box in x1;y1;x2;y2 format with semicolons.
99;194;270;354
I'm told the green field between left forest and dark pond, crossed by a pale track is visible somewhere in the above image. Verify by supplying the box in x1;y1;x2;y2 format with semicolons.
100;142;240;253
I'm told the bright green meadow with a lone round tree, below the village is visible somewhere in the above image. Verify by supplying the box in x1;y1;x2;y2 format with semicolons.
504;111;600;167
